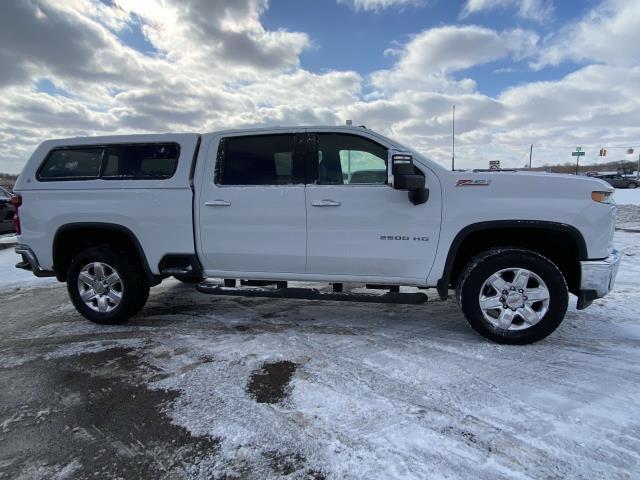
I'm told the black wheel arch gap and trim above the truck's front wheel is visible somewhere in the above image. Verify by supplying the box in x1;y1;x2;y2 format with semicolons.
437;220;588;299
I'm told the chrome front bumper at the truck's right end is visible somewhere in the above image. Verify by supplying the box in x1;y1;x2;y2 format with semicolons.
578;249;620;310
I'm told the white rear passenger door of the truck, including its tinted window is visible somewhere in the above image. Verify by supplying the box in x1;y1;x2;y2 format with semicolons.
196;130;306;278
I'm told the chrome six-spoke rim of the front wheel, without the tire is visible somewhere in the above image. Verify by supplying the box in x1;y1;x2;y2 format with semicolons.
478;268;551;330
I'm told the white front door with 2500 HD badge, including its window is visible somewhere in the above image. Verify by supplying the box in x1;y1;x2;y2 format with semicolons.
306;133;441;283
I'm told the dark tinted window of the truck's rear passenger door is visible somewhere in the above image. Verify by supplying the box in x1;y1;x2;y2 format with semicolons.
215;134;305;185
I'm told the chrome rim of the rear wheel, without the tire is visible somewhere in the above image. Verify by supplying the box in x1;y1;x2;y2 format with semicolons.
78;262;123;313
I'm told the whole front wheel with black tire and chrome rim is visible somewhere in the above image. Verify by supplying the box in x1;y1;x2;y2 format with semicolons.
457;249;569;345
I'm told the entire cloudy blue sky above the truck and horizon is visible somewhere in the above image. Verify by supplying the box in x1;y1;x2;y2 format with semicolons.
0;0;640;173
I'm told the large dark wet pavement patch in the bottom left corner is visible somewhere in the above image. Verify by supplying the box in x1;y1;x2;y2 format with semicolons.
0;348;219;479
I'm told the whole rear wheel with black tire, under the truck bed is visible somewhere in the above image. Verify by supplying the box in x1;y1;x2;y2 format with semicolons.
67;245;149;324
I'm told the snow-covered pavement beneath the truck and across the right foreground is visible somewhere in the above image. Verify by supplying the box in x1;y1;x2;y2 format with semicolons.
0;231;640;480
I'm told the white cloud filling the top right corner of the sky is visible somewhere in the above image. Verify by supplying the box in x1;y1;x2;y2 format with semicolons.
534;0;640;68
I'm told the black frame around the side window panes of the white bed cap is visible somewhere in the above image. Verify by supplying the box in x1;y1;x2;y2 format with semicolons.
35;142;182;182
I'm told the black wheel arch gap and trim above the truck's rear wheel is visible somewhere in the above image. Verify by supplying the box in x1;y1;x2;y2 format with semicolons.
52;222;162;285
